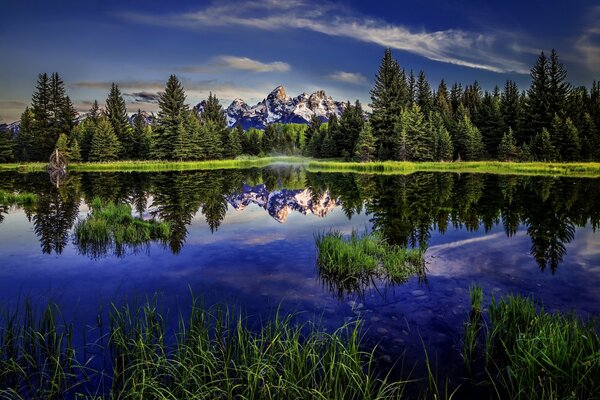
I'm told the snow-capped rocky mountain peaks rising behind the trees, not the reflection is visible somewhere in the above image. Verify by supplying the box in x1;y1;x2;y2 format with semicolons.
204;86;345;129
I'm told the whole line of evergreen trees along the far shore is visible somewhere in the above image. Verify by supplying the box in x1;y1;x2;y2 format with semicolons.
0;49;600;162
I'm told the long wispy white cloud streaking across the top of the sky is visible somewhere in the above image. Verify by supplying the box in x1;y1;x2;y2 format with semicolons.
121;0;529;73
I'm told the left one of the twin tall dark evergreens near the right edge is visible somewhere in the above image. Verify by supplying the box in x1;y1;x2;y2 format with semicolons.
523;52;553;141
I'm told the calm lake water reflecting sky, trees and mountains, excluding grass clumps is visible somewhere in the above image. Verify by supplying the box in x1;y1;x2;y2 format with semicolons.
0;167;600;382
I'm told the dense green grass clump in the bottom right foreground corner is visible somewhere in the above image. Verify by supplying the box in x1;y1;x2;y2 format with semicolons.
472;295;600;399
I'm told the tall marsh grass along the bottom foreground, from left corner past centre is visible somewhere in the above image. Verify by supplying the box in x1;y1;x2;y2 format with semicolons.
0;301;404;399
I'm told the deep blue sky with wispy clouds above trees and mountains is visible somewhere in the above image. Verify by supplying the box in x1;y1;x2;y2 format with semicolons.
0;0;600;123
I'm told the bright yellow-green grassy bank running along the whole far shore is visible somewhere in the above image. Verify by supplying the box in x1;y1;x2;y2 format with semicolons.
0;156;600;178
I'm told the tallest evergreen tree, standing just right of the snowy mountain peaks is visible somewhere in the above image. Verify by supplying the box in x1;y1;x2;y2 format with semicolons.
369;49;403;159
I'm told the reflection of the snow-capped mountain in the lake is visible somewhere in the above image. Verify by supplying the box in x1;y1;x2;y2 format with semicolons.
226;184;340;224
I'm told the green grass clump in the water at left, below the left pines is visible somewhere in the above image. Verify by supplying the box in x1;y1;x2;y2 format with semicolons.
75;198;171;256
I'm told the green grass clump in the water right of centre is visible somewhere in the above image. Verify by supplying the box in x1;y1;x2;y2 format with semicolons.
315;231;425;293
